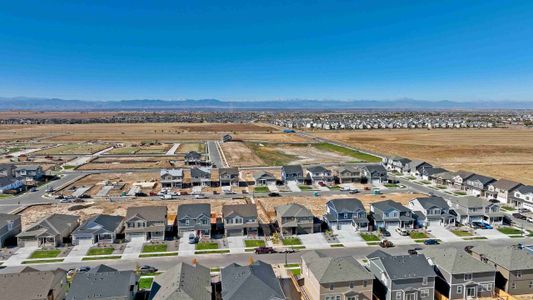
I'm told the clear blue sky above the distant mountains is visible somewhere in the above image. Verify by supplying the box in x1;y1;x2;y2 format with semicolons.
0;0;533;101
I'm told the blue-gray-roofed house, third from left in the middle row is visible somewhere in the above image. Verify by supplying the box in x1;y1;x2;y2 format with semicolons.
72;215;124;245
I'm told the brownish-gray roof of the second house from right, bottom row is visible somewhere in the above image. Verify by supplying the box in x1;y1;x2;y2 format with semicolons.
422;248;496;274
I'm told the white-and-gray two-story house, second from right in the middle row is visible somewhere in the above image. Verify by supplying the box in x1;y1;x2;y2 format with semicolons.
409;196;455;227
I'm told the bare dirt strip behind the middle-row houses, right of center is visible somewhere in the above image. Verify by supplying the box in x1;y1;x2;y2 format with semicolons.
257;193;427;220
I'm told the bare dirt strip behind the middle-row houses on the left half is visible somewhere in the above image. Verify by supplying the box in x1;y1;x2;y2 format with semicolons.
20;199;246;230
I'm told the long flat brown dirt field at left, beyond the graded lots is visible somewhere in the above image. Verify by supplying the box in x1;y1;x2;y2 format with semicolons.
0;123;308;143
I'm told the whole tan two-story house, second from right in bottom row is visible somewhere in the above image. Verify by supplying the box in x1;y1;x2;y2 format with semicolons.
423;248;496;299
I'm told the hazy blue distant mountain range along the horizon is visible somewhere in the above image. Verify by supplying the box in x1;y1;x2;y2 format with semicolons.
0;97;533;111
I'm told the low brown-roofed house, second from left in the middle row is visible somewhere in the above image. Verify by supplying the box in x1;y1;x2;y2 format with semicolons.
17;214;79;247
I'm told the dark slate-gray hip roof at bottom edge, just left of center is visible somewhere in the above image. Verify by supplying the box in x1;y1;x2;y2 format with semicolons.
220;261;286;300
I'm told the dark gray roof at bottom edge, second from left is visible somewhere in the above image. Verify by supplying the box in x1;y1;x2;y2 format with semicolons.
67;266;138;300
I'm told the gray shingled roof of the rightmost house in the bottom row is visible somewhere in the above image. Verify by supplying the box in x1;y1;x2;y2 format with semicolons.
472;244;533;271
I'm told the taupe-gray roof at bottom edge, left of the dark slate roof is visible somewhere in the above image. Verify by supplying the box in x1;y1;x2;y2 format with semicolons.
150;262;211;300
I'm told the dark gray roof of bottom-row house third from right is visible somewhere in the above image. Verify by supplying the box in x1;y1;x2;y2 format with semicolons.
367;251;437;280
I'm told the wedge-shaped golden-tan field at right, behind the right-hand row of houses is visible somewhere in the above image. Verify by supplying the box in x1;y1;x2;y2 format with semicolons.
315;128;533;184
